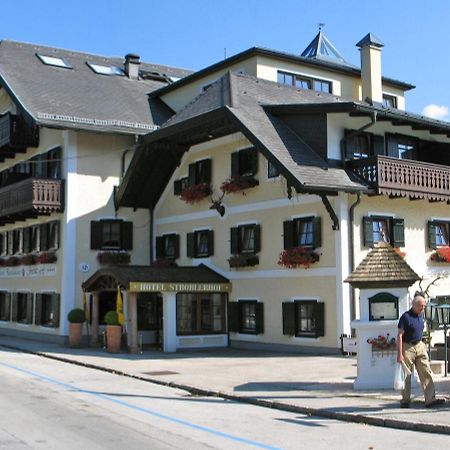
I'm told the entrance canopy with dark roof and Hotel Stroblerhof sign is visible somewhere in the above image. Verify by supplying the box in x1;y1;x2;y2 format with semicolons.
82;264;231;292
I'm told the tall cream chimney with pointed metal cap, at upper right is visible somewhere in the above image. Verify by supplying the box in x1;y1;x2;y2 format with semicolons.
356;33;384;104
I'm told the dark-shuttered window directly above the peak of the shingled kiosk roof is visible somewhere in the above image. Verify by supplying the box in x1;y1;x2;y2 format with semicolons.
363;216;405;247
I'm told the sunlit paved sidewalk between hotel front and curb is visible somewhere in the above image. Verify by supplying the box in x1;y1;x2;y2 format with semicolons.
0;336;450;434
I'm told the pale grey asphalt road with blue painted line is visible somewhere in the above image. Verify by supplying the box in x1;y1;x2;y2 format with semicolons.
0;349;449;450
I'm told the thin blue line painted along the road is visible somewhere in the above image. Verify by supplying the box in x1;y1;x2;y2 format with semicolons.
0;362;282;450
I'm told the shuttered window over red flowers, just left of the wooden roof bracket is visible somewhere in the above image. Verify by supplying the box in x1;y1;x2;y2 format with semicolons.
283;217;322;250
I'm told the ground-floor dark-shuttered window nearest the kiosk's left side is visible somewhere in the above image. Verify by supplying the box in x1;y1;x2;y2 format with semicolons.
283;300;325;338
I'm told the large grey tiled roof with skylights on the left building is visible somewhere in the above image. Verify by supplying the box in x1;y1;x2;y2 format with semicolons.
0;40;191;134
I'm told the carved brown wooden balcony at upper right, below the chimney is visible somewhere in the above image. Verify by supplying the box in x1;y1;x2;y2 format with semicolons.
346;156;450;202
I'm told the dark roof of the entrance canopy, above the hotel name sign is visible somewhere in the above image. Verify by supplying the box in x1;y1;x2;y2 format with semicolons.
83;264;230;291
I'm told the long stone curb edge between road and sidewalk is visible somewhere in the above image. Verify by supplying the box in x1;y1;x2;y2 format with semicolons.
0;344;450;435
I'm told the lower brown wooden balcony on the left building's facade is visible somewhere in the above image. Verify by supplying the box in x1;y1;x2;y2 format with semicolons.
0;178;64;225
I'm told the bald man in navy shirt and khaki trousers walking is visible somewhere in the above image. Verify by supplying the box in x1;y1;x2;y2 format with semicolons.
397;292;445;408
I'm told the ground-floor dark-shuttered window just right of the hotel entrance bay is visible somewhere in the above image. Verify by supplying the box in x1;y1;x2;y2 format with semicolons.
228;300;264;334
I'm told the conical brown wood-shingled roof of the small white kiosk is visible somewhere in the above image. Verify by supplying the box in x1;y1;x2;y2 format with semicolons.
345;241;420;288
